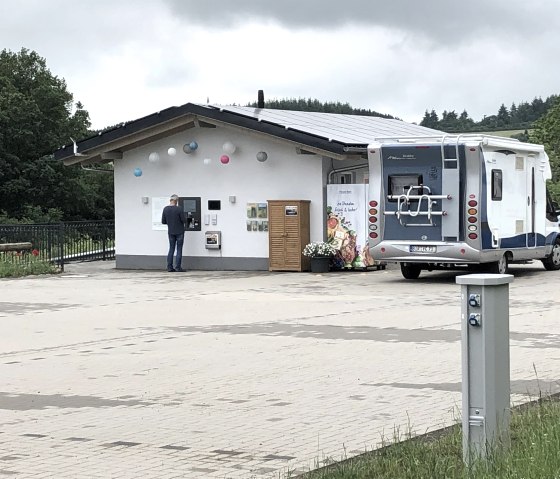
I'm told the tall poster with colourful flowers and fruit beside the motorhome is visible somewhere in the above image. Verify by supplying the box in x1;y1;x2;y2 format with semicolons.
327;184;374;268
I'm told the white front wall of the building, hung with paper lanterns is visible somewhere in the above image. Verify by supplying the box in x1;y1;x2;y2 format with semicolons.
115;123;324;258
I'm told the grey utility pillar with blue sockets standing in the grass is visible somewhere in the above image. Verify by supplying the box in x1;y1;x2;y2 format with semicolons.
456;274;513;465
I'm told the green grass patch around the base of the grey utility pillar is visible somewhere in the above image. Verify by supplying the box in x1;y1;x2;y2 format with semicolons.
305;399;560;479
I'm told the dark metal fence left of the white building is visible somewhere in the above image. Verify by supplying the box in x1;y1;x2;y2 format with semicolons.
0;221;115;270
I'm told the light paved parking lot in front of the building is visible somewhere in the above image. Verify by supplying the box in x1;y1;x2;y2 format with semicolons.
0;262;560;478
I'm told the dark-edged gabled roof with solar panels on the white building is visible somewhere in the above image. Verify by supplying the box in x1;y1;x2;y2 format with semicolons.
54;103;441;160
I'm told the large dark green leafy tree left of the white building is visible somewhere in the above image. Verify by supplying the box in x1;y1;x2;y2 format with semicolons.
0;49;112;220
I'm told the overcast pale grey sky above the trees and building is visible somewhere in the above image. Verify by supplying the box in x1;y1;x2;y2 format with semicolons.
0;0;560;128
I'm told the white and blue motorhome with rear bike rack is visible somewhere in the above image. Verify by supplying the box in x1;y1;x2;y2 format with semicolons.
368;135;560;279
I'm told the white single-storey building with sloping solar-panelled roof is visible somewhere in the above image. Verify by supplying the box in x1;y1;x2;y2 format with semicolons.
55;103;439;270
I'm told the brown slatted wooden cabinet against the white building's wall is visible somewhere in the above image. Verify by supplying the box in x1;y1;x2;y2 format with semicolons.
268;200;310;271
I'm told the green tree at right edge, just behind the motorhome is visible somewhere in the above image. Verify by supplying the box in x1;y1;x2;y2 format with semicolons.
530;97;560;202
